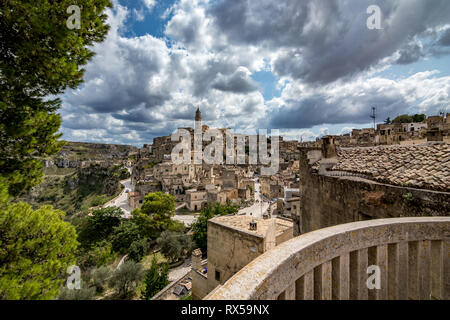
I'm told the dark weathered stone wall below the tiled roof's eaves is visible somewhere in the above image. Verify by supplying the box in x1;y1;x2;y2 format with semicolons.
293;149;450;235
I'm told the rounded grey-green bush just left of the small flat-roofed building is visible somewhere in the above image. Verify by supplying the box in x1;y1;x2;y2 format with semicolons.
156;231;193;262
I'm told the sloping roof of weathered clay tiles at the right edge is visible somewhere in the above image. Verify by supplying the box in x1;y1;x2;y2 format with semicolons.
331;143;450;192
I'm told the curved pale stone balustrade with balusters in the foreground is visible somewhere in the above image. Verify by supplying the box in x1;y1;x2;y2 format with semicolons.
205;217;450;300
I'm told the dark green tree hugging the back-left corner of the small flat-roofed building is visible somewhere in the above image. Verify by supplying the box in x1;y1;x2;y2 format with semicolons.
192;203;239;252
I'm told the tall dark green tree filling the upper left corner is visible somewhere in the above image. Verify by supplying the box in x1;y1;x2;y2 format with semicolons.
0;0;111;195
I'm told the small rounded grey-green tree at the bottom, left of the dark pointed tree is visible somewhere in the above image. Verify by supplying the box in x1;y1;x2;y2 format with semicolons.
109;261;144;298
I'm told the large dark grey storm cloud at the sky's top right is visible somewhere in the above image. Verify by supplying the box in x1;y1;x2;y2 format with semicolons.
209;0;450;83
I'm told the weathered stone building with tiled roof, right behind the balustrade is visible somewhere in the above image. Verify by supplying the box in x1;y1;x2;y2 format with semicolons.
294;143;450;234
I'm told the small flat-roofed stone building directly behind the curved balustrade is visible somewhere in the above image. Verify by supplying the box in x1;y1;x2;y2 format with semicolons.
191;215;293;299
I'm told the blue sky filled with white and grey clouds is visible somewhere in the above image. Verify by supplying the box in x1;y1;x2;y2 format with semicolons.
60;0;450;146
